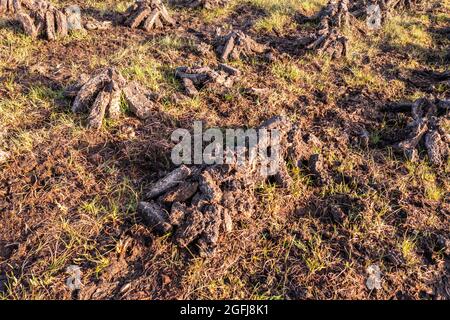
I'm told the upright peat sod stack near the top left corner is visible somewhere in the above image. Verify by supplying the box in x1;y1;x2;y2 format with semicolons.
12;0;68;40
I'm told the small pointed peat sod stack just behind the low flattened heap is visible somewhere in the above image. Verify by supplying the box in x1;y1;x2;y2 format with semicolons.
214;30;267;62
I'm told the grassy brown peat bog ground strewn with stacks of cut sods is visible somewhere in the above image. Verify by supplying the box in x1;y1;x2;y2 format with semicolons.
0;0;450;299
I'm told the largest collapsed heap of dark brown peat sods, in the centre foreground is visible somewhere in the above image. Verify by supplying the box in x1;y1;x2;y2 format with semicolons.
138;117;299;256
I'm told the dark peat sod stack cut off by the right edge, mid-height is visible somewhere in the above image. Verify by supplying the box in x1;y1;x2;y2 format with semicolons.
387;98;450;166
